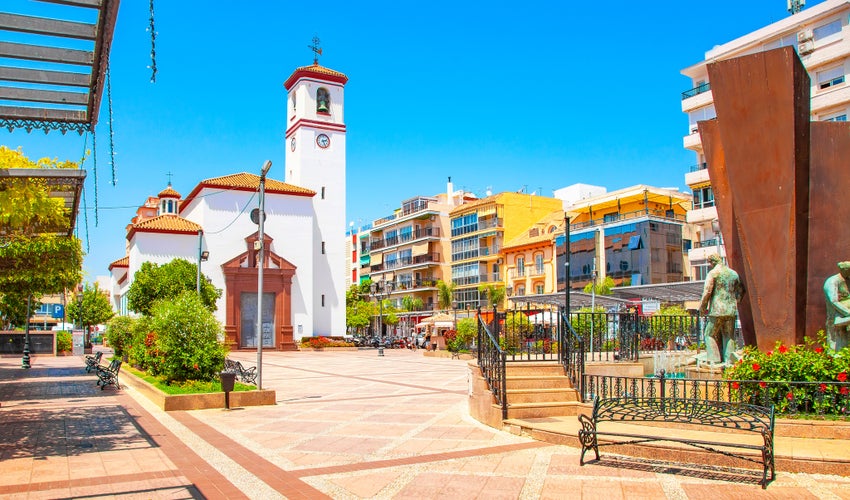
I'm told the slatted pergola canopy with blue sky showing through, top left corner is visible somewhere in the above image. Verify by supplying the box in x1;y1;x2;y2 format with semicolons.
0;0;119;134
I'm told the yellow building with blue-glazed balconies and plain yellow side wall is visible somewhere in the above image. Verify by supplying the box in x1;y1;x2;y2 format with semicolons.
449;192;563;309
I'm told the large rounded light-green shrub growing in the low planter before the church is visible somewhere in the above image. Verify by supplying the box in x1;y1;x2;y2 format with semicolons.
146;292;227;382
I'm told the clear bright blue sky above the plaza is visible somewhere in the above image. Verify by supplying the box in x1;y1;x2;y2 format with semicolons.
0;0;820;280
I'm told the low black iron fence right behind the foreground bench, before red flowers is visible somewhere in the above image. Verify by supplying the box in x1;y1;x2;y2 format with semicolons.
581;372;850;419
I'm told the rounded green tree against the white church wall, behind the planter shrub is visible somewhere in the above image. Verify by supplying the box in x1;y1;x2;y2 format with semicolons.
127;259;221;315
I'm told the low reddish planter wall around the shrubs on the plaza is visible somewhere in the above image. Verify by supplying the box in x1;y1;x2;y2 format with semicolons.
119;371;276;411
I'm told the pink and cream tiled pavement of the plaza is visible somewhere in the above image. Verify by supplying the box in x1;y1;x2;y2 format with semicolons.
0;350;850;500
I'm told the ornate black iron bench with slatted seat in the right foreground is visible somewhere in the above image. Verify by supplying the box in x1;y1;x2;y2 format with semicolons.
578;397;776;488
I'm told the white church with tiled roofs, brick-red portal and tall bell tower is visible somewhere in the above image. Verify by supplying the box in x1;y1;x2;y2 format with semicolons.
109;60;348;350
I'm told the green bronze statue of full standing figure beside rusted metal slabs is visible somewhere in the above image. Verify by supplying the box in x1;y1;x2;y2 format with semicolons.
700;255;744;365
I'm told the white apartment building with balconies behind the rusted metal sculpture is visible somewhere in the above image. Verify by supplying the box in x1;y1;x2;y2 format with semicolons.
682;0;850;280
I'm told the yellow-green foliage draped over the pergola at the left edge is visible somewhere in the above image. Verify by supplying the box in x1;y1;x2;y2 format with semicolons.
0;146;83;312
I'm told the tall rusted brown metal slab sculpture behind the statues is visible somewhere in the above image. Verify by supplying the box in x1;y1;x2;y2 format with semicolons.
699;47;850;350
